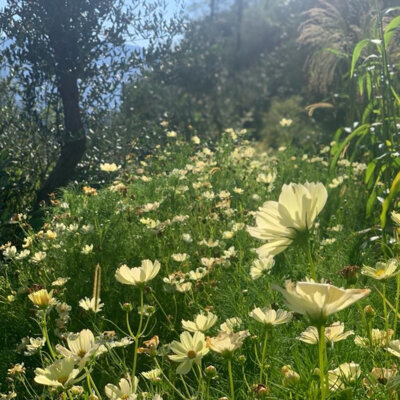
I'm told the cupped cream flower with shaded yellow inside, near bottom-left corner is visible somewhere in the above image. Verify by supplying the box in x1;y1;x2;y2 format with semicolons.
34;358;80;388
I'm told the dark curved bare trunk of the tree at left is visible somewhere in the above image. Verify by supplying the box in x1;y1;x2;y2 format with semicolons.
37;72;86;202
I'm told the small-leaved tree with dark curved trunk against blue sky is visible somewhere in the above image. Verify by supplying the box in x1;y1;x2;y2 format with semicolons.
0;0;181;201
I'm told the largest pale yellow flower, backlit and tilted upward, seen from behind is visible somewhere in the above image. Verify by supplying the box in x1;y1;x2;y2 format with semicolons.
247;182;328;257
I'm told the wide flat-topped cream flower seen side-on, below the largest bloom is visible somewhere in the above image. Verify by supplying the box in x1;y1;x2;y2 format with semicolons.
273;281;370;323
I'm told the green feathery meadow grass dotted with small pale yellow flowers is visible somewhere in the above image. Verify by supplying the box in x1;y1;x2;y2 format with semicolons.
1;130;397;399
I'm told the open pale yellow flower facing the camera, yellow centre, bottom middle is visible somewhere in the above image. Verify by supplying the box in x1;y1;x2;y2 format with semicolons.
169;331;209;374
